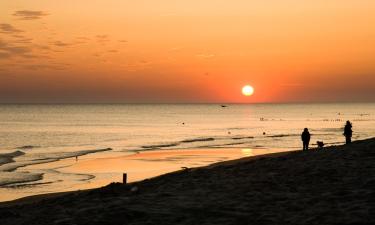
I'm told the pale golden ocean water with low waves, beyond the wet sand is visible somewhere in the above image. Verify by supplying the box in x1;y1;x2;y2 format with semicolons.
0;103;375;199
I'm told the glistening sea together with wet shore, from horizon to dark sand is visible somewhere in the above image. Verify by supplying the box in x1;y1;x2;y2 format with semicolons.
0;103;375;202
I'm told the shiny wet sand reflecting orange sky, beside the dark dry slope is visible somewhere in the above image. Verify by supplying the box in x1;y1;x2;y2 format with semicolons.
0;148;290;202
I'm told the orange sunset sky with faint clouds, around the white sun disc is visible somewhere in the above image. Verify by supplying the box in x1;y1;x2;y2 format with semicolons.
0;0;375;103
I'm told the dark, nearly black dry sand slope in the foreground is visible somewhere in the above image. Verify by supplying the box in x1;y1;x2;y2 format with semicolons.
0;139;375;225
